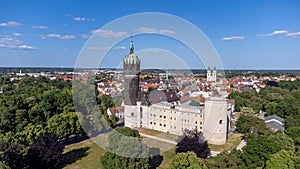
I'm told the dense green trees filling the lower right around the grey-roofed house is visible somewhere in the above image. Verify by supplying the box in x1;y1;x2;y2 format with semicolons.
207;79;300;169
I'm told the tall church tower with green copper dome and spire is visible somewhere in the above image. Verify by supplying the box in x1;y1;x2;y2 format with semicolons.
123;37;140;128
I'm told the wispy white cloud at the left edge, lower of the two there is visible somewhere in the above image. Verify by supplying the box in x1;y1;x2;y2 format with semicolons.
0;36;36;50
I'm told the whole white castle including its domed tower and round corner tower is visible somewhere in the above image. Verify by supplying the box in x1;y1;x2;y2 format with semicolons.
123;39;233;144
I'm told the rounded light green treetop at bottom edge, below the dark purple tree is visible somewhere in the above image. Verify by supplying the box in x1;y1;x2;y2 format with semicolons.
169;152;207;169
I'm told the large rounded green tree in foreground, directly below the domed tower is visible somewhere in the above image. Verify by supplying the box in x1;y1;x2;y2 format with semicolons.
100;127;150;169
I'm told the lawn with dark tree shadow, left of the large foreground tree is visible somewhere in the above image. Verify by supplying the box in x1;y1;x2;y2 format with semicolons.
63;139;105;169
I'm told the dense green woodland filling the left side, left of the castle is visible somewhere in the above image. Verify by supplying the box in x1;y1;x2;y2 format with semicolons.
0;76;118;168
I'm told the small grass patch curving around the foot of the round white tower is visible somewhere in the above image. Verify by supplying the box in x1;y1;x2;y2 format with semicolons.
208;133;243;152
